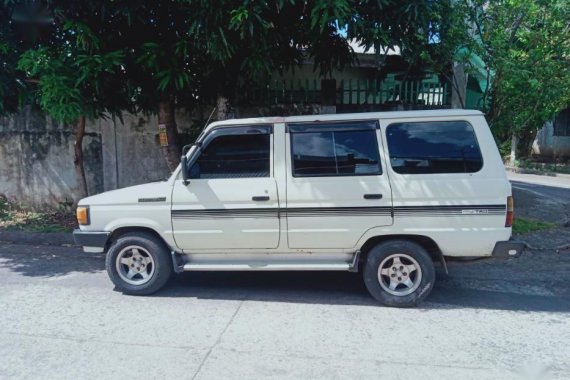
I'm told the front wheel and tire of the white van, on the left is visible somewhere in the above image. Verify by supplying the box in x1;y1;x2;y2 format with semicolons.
105;232;173;296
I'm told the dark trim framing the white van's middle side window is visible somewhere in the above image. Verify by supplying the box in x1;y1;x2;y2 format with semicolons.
285;119;384;178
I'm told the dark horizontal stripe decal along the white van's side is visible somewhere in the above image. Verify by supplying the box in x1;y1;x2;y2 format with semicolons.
172;205;507;219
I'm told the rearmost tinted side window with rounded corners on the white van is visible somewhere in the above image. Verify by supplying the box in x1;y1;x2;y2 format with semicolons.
386;121;483;174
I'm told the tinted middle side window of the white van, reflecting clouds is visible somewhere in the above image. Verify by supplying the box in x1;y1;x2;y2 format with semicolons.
289;122;382;177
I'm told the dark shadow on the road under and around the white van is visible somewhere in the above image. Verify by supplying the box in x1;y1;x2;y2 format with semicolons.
0;245;570;313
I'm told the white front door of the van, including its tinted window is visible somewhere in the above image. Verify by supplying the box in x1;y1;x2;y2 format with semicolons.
172;125;280;251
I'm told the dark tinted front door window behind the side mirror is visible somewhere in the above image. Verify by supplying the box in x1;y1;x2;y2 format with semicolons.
190;128;270;179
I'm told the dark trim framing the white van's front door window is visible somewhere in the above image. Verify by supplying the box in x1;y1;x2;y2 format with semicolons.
186;124;274;181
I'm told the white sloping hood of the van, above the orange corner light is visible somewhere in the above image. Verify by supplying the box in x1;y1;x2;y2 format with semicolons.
79;181;172;206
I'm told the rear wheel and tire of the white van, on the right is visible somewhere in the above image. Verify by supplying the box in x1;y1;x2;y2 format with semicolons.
364;240;435;307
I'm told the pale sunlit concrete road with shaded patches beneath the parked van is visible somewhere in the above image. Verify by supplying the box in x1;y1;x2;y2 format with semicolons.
0;243;570;379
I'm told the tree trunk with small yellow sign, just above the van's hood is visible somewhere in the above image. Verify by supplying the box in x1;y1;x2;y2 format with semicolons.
158;96;182;172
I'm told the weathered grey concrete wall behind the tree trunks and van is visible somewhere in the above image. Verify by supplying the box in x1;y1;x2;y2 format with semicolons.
0;105;321;209
